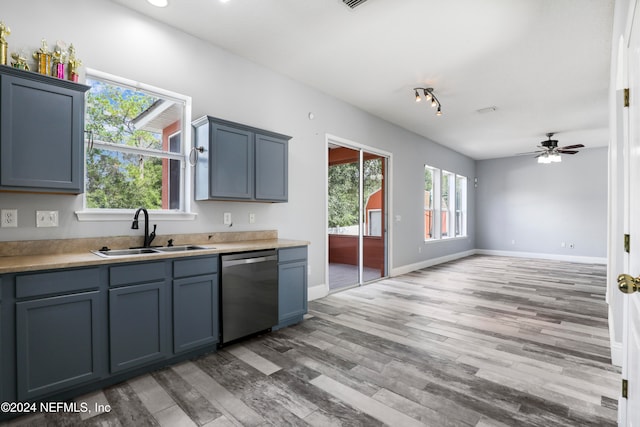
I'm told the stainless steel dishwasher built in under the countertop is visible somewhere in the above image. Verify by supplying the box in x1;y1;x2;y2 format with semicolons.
220;250;278;344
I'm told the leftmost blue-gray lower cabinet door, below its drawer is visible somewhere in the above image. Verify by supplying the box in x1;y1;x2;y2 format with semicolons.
16;291;106;401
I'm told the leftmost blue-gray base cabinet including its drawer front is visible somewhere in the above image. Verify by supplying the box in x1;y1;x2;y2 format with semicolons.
15;268;106;401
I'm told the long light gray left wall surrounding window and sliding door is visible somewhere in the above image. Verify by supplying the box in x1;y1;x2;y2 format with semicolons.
0;0;475;286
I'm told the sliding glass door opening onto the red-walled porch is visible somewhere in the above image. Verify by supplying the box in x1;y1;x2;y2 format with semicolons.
327;144;387;291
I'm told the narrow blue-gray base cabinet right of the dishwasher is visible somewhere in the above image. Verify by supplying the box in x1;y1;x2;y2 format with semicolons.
274;246;307;329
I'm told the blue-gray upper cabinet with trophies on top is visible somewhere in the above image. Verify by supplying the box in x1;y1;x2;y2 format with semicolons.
0;66;89;194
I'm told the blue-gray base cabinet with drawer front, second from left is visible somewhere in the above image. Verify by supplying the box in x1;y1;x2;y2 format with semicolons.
109;262;170;373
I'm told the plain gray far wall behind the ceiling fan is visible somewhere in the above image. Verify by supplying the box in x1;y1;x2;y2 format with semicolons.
476;147;608;259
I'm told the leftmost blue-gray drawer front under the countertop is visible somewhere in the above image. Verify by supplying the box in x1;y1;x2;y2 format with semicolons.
16;268;100;298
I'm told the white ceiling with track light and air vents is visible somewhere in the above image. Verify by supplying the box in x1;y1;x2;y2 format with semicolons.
113;0;614;159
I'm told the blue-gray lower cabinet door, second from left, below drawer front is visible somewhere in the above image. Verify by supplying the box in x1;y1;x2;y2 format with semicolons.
109;281;169;373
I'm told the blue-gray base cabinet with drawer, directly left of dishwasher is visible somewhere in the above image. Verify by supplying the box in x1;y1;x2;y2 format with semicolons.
173;256;220;354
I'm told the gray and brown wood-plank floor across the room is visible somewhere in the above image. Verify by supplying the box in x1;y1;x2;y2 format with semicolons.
2;256;620;427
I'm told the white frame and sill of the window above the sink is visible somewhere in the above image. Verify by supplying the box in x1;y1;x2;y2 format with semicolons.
76;68;197;221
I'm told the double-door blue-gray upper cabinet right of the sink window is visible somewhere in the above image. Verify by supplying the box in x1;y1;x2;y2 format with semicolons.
193;116;291;202
